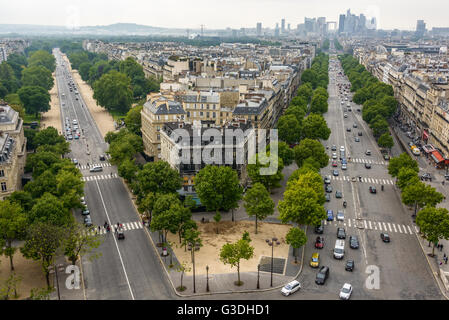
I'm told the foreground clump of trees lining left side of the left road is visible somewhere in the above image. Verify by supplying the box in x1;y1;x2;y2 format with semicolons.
0;127;100;298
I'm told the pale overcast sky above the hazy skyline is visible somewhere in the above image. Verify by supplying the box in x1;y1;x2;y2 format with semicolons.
0;0;449;30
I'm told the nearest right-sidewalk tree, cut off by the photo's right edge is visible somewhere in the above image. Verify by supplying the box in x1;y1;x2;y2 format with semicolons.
416;207;449;256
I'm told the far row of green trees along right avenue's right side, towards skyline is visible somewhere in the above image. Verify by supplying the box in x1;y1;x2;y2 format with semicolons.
339;54;398;149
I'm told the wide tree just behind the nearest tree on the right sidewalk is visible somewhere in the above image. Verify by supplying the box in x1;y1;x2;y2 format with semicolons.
401;181;444;215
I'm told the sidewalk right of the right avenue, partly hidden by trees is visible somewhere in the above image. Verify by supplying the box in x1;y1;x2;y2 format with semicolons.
391;121;449;299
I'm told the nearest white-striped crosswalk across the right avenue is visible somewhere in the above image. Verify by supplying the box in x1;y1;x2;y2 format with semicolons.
324;219;419;234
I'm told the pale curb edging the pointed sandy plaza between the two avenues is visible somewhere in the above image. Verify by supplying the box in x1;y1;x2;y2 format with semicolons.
120;177;307;298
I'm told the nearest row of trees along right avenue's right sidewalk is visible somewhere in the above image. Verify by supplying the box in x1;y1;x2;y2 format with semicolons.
388;152;449;254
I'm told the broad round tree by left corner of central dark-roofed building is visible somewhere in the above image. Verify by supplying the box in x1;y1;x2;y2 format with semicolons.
136;161;182;199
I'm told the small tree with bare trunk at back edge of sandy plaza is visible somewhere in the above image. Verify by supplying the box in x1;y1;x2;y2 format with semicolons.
243;183;274;234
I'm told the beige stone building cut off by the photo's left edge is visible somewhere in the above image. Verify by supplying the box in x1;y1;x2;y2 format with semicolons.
0;101;26;200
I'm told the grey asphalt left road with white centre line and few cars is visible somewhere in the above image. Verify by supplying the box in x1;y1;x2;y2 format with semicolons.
54;49;175;300
